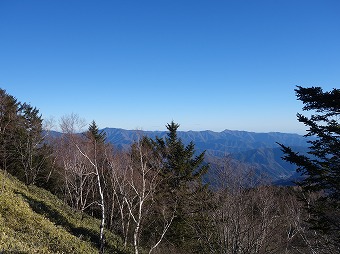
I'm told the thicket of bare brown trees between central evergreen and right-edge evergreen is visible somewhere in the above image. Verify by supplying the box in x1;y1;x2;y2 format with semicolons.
205;157;337;254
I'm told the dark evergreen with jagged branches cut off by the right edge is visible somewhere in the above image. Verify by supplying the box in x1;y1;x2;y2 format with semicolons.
280;86;340;248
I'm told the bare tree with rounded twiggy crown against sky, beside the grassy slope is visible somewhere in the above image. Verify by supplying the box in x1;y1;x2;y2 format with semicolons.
55;114;107;253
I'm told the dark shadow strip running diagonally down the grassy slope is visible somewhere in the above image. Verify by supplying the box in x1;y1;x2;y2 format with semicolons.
15;192;127;254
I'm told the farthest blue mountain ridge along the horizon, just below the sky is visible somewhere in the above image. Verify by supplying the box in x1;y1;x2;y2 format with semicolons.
101;128;307;153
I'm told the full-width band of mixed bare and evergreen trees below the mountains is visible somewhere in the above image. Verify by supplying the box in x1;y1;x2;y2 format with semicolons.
0;87;340;254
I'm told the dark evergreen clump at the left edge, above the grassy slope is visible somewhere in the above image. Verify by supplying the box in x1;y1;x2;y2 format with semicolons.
0;89;52;184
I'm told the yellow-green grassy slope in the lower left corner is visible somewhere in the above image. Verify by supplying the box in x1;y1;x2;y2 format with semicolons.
0;170;129;254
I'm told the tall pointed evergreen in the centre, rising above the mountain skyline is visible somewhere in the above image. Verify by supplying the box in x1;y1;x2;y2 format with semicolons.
155;121;209;251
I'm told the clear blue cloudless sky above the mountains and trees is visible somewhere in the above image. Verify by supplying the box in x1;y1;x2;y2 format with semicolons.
0;0;340;133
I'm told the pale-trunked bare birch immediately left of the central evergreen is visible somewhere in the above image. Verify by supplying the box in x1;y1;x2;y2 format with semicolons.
106;138;175;254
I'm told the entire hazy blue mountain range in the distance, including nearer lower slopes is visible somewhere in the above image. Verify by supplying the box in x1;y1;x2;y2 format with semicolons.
99;128;308;182
